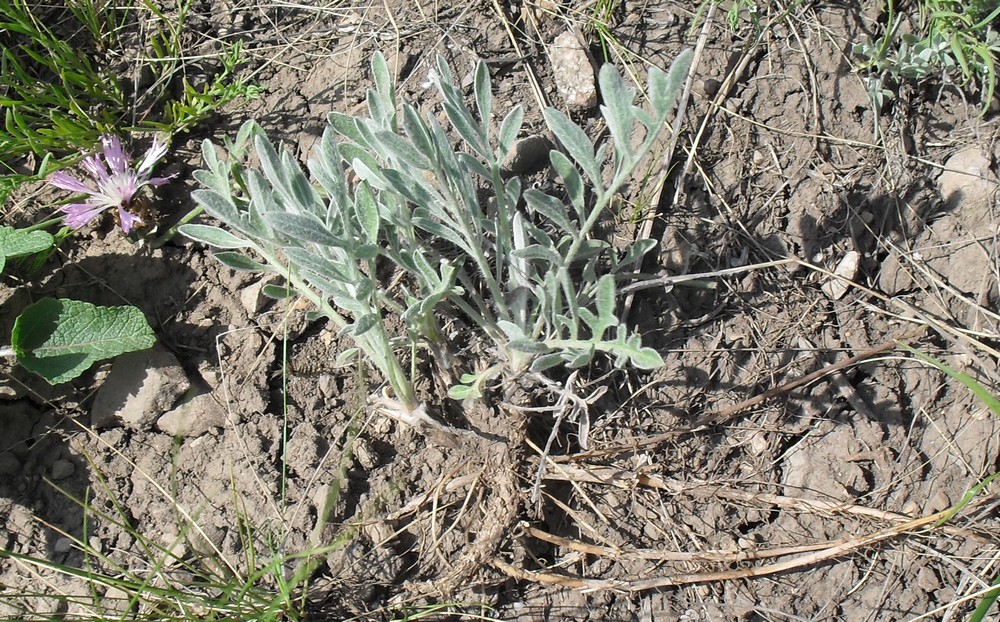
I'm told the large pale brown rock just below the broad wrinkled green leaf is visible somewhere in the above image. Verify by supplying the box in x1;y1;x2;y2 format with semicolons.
90;350;191;430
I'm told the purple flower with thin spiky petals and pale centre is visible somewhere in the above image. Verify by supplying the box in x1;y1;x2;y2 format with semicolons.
49;136;173;233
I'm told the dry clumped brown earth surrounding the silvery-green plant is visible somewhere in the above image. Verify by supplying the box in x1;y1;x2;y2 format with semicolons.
0;1;1000;622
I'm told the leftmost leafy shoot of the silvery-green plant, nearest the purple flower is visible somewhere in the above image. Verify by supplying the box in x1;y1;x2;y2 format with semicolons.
181;122;422;417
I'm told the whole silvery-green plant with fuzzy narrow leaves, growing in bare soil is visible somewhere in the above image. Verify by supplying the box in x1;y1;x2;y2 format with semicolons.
182;52;690;410
